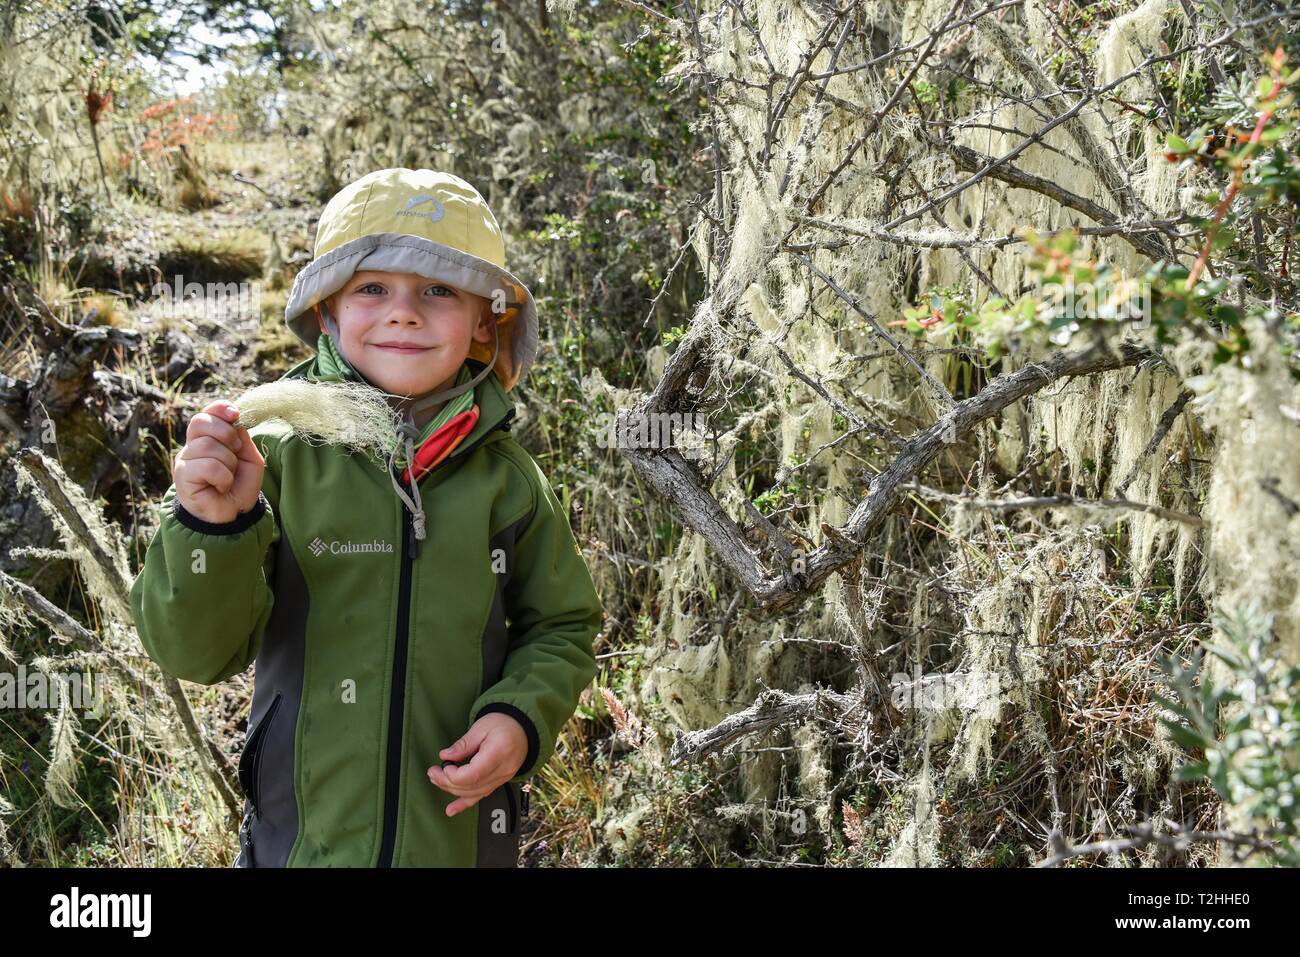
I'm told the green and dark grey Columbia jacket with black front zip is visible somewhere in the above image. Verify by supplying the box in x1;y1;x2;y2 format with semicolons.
131;355;603;867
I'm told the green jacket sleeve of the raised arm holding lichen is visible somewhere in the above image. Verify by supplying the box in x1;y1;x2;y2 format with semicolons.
131;426;280;684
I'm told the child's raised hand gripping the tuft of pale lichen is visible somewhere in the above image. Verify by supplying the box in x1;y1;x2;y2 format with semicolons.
172;400;267;524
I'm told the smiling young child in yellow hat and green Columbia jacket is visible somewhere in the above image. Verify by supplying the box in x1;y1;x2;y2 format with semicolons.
131;168;603;867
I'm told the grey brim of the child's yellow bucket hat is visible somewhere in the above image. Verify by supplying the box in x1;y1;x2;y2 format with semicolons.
285;233;537;391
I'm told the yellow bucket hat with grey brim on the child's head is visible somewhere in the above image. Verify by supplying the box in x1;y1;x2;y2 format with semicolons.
285;166;537;400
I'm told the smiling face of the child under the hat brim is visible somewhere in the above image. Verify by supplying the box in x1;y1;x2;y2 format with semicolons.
325;270;493;395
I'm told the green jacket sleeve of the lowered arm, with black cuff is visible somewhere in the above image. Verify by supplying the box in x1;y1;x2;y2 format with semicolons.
471;456;605;783
